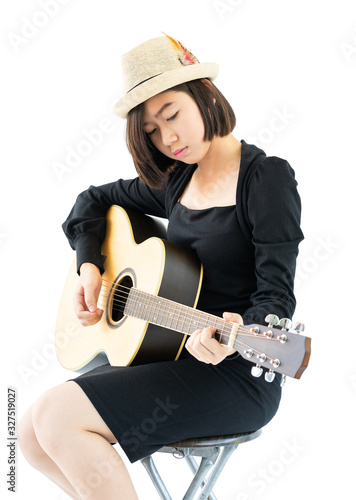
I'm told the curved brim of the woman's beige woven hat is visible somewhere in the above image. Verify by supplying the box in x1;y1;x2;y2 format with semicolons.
113;63;219;118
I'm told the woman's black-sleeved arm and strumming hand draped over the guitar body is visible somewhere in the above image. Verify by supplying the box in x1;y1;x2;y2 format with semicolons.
62;179;166;326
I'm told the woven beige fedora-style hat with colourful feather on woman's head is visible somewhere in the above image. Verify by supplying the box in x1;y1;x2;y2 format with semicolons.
113;35;219;118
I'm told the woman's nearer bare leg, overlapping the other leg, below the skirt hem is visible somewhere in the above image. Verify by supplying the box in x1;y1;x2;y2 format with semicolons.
18;382;137;500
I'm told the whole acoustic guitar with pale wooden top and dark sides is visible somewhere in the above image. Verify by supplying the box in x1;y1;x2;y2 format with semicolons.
55;205;311;382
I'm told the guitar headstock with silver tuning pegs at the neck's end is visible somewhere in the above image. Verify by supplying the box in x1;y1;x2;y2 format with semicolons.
234;314;311;382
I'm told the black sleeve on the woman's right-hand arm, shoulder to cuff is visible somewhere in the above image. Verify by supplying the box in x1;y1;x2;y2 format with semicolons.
243;157;303;324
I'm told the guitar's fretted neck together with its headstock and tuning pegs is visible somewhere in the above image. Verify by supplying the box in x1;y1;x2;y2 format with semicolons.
124;288;310;381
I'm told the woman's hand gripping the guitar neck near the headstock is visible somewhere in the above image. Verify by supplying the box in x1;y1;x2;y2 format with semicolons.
185;312;243;365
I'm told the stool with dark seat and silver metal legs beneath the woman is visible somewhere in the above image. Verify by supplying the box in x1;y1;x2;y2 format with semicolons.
141;429;262;500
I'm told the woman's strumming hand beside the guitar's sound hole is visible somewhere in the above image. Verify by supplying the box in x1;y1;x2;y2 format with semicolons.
73;262;104;326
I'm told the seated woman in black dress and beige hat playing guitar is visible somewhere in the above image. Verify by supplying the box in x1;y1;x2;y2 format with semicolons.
19;36;303;499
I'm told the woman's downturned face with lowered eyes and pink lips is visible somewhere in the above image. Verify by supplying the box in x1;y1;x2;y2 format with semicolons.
143;90;210;164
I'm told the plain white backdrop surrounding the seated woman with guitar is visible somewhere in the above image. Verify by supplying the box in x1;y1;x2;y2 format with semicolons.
0;0;356;500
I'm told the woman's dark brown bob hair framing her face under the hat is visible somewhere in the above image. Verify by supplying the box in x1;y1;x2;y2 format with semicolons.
126;79;236;189
